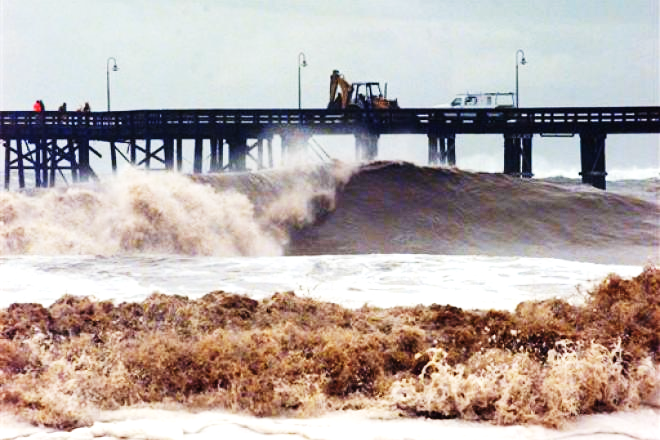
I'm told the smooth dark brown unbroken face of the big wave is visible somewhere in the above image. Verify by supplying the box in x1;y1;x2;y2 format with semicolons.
289;162;660;265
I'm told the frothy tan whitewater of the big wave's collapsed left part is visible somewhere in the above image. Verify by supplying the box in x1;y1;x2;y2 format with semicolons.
0;162;354;256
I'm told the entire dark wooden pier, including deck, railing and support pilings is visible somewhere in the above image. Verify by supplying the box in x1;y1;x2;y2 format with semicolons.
0;107;660;189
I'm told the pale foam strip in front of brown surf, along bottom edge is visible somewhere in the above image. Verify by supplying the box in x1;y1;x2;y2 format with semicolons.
0;407;660;440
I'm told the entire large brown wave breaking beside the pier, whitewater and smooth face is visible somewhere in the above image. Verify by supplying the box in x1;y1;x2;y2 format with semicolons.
0;162;660;265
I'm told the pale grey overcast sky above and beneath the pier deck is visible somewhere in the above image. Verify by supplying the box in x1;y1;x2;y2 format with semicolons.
0;0;660;177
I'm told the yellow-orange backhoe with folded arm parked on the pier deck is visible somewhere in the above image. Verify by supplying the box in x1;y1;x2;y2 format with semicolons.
328;70;399;110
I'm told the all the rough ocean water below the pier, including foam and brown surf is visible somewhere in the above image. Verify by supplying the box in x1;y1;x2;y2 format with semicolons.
0;162;660;439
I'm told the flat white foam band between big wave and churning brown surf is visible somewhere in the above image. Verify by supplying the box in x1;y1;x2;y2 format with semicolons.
0;254;642;310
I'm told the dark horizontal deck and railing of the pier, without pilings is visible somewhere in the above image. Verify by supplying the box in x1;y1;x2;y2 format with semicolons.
0;107;660;139
